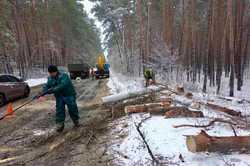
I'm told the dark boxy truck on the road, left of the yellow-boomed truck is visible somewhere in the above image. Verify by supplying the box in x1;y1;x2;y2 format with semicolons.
68;63;90;80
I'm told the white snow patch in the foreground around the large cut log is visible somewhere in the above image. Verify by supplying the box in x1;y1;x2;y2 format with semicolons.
110;114;250;166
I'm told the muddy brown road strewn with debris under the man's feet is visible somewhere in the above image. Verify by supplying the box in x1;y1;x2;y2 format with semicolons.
0;80;120;166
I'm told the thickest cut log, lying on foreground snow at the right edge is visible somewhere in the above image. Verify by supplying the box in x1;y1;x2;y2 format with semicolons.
186;130;250;154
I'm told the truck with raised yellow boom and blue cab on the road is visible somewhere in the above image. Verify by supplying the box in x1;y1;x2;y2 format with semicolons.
95;55;110;79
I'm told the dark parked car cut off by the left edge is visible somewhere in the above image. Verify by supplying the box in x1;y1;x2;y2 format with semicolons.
0;75;30;106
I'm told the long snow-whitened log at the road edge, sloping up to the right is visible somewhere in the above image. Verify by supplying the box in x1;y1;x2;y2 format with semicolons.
102;86;167;104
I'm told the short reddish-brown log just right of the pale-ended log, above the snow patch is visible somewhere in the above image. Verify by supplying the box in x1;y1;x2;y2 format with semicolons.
165;107;204;118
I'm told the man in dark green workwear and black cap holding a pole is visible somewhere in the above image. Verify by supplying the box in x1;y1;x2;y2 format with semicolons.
43;65;80;132
